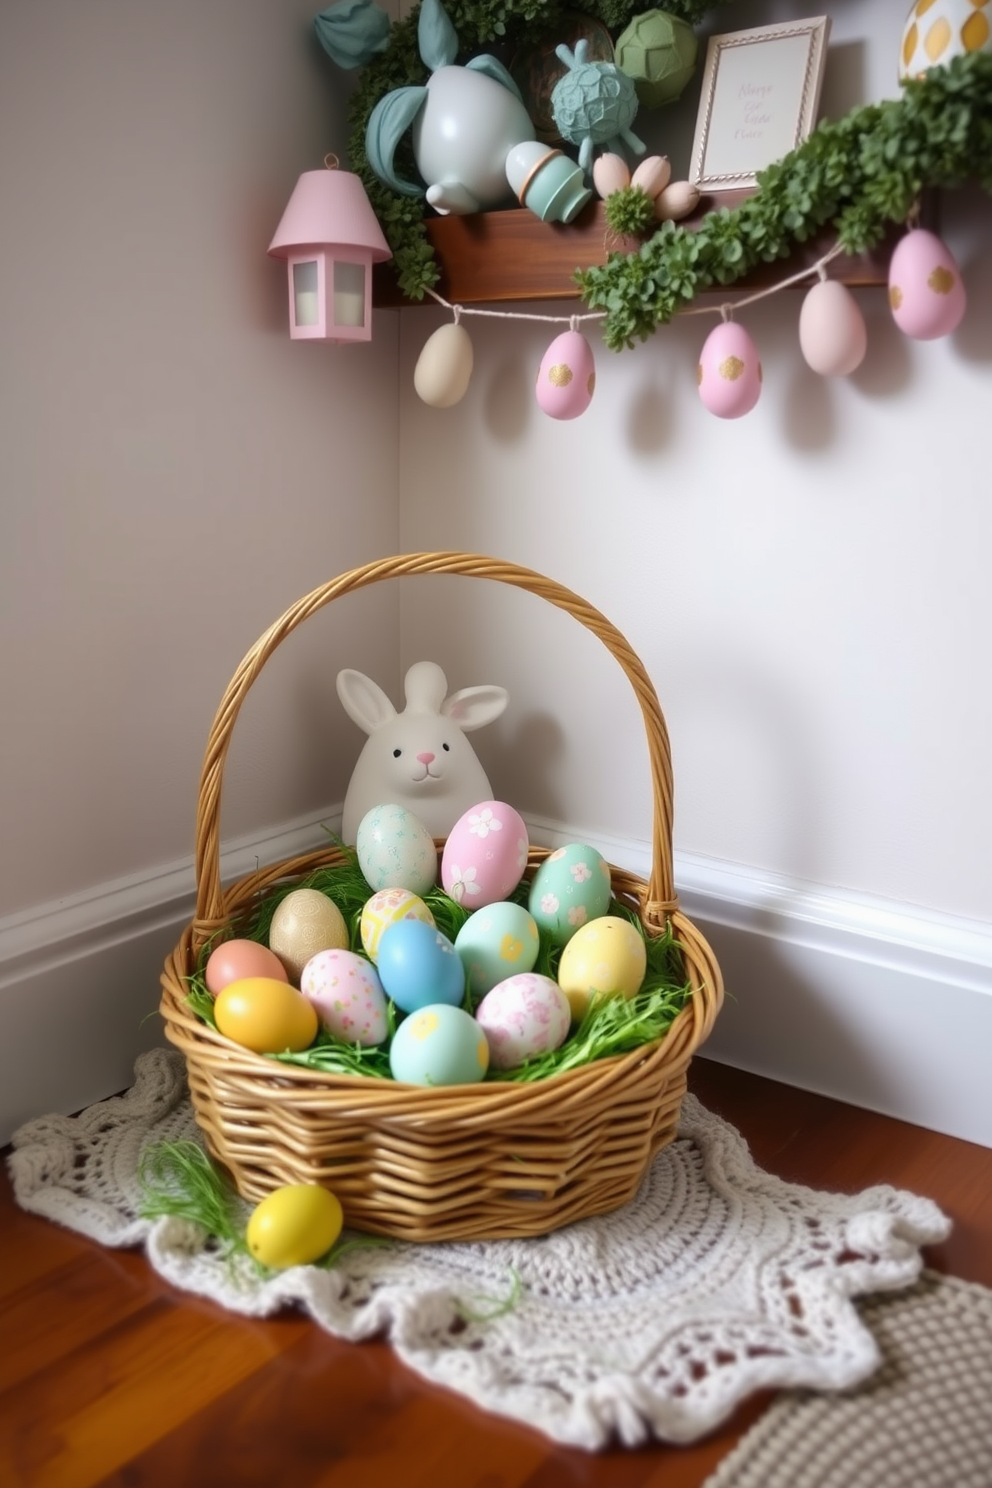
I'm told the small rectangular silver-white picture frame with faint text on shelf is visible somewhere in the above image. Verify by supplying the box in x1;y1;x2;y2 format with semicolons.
690;15;830;192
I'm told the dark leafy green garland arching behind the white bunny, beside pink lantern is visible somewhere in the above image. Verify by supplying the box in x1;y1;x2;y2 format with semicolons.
348;0;732;301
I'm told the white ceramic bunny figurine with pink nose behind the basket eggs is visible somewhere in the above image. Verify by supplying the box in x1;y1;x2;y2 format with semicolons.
338;661;509;844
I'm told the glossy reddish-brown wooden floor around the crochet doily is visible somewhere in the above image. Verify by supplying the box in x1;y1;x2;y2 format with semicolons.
0;1058;992;1488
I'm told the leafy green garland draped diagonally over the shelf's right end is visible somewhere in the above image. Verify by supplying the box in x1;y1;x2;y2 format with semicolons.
576;52;992;351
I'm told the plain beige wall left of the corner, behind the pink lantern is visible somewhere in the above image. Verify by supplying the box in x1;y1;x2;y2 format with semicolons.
0;0;397;917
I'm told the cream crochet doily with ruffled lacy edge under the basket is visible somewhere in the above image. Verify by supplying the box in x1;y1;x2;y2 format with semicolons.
9;1049;950;1449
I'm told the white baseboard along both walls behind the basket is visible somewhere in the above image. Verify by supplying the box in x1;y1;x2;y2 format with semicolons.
0;806;992;1147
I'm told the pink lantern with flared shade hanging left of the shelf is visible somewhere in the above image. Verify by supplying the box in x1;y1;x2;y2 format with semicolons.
269;155;393;342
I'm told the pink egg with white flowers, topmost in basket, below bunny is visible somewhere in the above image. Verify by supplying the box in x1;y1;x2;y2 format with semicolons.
440;801;531;909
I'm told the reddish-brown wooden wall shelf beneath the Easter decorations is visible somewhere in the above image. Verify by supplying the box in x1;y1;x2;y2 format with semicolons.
373;190;903;307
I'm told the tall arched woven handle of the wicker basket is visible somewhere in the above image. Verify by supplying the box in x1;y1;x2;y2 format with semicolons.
196;552;678;930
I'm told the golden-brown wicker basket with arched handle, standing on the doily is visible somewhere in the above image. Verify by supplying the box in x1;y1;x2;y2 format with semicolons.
161;552;723;1241
